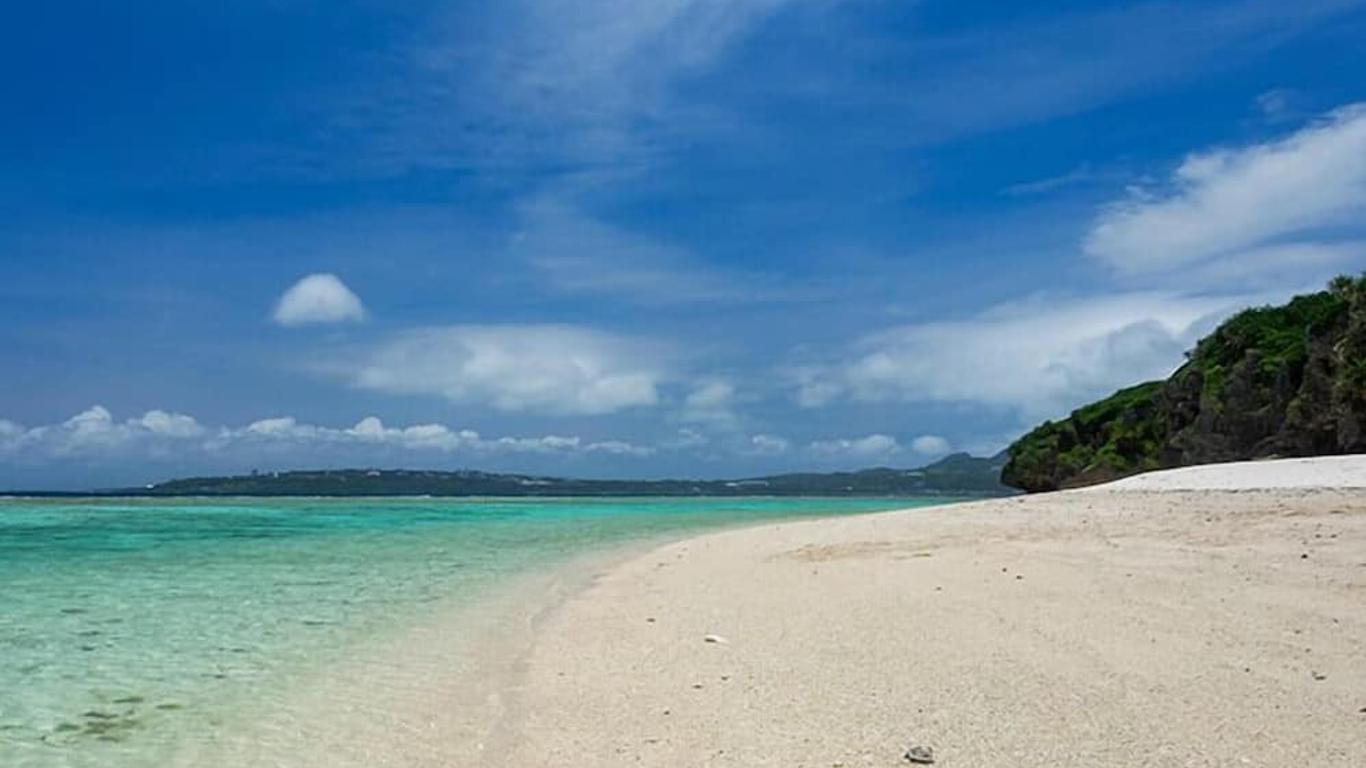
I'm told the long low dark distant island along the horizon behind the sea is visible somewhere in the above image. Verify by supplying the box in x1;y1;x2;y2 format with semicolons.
64;454;1014;496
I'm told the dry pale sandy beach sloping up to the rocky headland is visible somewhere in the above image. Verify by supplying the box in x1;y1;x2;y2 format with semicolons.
478;459;1366;768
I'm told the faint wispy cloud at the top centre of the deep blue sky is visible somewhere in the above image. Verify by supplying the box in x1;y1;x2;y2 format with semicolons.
337;0;802;172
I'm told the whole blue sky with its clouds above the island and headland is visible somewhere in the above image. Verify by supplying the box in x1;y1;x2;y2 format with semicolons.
0;0;1366;488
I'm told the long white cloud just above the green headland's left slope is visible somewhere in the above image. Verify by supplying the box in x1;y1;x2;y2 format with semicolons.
792;292;1249;418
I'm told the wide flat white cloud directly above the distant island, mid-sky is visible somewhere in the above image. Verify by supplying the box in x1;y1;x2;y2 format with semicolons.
354;325;664;414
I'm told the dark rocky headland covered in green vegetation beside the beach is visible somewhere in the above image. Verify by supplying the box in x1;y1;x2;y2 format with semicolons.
1001;275;1366;492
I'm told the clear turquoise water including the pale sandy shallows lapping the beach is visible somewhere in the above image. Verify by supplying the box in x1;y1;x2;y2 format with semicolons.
0;499;929;768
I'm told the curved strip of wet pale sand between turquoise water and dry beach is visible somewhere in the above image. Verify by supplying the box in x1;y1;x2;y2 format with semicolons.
168;507;945;768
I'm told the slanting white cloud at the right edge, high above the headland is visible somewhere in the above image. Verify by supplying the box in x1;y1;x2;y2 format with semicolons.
1083;104;1366;286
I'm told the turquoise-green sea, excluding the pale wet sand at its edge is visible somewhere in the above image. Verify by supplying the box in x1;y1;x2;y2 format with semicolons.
0;499;947;768
